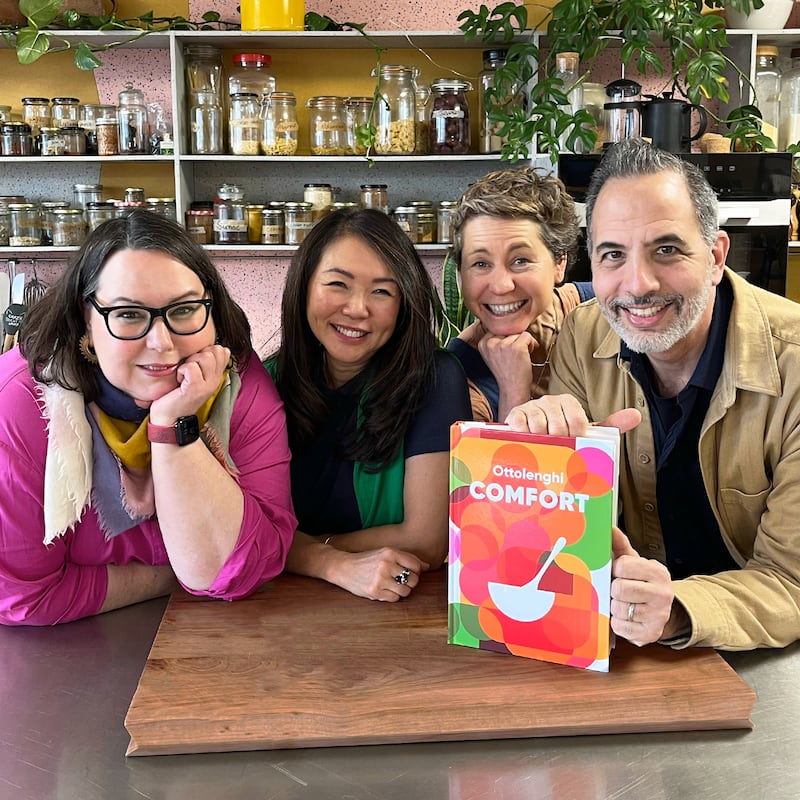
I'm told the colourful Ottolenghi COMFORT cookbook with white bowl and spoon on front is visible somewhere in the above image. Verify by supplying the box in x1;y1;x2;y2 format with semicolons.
448;422;620;672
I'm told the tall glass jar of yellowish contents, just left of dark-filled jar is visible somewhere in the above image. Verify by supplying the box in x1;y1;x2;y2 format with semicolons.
372;65;416;155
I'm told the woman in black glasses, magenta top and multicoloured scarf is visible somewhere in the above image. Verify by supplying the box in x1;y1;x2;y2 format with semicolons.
0;211;296;625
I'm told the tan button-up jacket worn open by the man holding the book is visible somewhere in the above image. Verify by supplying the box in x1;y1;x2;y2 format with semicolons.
550;269;800;650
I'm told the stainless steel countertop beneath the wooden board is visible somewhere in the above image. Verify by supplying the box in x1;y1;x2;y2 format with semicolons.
0;600;800;800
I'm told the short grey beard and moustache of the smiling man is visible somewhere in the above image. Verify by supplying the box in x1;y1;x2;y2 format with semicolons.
600;262;713;353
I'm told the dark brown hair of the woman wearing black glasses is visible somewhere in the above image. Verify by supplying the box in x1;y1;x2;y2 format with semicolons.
20;209;252;400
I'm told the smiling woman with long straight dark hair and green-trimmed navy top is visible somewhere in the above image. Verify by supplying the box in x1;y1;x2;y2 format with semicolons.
267;209;471;601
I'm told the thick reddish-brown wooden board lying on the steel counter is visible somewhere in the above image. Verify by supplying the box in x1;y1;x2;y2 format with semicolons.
125;570;755;755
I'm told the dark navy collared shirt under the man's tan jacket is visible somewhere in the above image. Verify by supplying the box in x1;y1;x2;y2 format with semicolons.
620;279;738;579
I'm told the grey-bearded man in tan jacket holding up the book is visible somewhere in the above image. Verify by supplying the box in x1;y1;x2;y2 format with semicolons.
507;140;800;650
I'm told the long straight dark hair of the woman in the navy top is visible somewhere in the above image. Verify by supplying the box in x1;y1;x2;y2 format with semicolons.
277;209;436;470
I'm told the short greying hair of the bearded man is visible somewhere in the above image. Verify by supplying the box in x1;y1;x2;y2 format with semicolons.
586;139;719;250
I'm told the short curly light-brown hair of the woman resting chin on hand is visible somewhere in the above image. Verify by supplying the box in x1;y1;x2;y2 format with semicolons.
450;167;578;268
